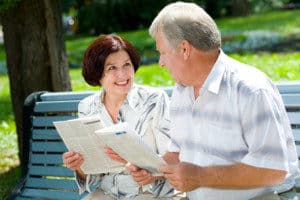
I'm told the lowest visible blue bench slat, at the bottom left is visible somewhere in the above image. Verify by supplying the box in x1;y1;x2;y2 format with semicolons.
22;188;80;199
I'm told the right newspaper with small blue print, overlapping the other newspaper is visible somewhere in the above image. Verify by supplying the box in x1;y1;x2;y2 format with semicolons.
95;122;166;176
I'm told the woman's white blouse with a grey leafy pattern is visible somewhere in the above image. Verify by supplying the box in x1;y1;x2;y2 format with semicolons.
76;85;173;199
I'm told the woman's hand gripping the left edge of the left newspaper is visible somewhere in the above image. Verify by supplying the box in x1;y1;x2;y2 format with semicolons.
62;151;83;171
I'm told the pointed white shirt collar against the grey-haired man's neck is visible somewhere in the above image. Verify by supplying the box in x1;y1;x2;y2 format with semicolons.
200;50;226;94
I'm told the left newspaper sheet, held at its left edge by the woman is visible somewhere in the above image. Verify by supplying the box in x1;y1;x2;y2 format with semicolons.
53;117;125;174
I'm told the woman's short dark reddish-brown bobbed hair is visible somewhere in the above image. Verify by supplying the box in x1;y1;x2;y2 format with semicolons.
82;34;140;86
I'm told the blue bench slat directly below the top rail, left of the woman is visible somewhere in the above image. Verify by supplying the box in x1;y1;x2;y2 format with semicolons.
34;100;79;113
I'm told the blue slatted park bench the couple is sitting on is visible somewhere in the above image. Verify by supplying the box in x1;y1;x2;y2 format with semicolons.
9;82;300;200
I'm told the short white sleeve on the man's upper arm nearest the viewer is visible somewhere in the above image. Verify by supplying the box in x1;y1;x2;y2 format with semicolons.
240;89;288;171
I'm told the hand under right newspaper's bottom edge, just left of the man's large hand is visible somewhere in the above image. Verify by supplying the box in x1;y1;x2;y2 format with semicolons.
126;163;163;185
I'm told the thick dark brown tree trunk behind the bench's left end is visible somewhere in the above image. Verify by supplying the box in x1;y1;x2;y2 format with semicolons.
0;0;71;175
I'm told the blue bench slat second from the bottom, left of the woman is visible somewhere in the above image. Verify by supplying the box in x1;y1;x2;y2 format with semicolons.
25;177;78;192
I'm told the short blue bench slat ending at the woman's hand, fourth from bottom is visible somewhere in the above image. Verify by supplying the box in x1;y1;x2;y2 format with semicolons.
30;153;63;165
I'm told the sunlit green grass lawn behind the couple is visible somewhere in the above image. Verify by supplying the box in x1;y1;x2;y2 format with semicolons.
0;10;300;199
